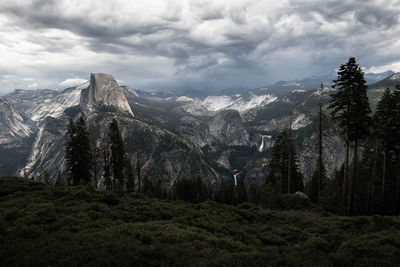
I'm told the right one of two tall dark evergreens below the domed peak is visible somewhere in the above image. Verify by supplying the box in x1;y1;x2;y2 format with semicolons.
108;119;125;191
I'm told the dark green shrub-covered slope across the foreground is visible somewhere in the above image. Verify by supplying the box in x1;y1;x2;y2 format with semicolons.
0;178;400;266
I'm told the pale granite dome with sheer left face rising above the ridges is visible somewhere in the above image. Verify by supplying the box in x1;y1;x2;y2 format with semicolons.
80;73;133;116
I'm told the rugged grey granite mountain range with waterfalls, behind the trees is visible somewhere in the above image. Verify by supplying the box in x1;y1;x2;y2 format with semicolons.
0;71;400;185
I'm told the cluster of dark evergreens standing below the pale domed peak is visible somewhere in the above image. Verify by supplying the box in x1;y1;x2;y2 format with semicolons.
64;117;134;192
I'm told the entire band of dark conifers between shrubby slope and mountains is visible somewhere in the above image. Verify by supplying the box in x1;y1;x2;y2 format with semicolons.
57;58;400;215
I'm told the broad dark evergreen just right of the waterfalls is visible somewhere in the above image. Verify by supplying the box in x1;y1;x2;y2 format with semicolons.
266;131;304;194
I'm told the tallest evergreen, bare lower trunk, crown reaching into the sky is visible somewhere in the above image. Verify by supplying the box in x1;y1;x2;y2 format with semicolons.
329;57;371;215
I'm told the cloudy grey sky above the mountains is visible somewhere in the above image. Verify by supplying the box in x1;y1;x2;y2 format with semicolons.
0;0;400;94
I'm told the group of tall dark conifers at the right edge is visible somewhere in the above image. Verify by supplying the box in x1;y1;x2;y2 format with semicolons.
307;58;400;215
